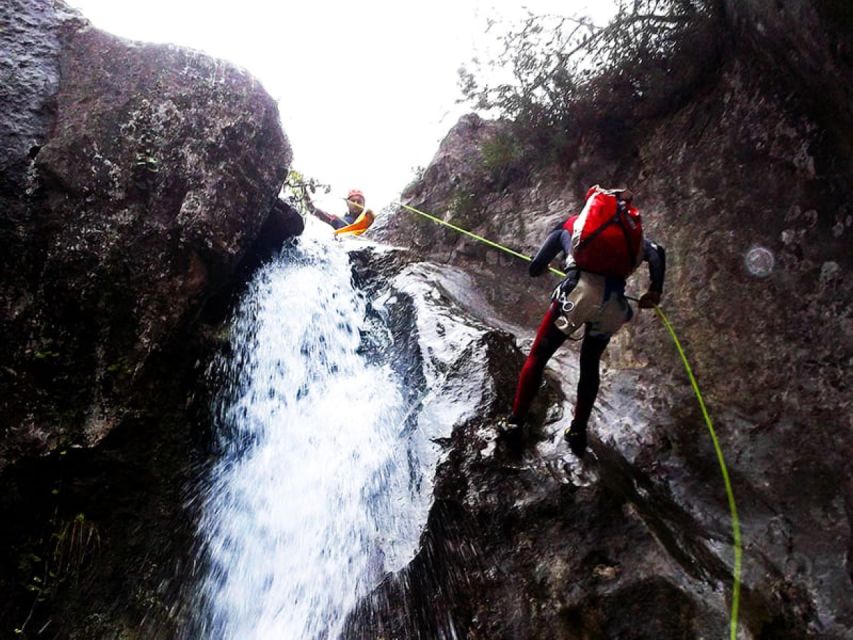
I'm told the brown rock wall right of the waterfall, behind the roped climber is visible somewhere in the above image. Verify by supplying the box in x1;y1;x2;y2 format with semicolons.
368;1;853;638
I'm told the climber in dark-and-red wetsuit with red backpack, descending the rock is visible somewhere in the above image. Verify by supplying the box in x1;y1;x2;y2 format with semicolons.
503;187;666;457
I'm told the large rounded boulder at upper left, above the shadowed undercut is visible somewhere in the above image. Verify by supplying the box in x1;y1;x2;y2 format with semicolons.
0;0;291;467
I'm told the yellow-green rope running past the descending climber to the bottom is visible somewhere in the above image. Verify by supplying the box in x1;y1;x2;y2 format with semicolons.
397;202;743;640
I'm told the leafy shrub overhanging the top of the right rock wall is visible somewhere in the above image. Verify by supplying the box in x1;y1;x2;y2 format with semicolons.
459;0;722;164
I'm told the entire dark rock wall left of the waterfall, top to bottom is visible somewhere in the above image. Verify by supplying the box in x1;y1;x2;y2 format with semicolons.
0;0;301;638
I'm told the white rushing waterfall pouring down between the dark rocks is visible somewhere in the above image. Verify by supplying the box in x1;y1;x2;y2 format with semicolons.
191;225;433;640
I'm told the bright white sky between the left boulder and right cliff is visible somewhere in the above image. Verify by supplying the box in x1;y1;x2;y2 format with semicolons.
69;0;609;213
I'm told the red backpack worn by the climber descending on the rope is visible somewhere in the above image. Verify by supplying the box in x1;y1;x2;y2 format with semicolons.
563;185;643;278
